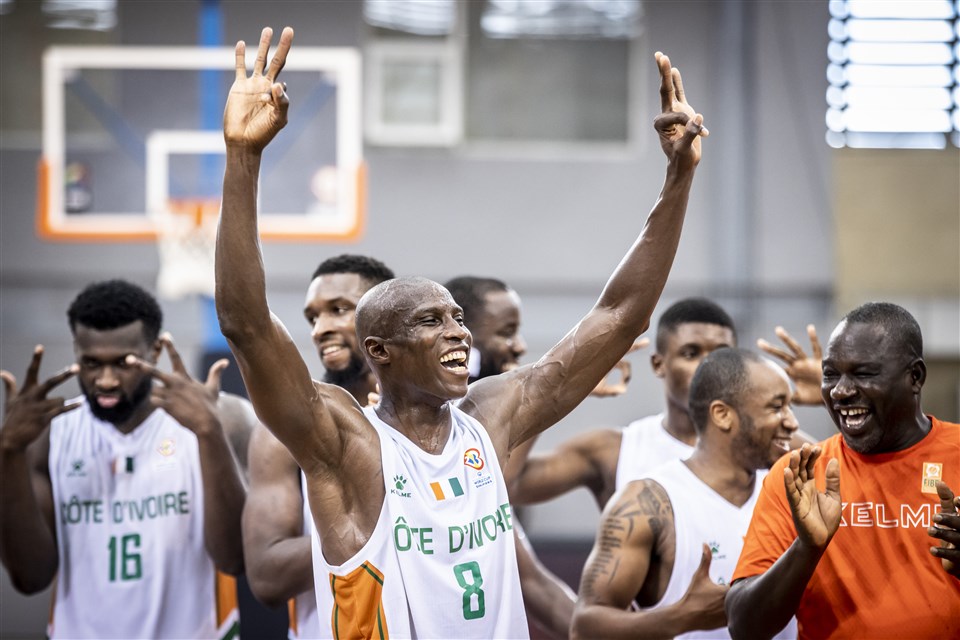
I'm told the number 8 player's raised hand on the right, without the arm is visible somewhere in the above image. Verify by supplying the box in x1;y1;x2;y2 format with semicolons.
653;51;710;168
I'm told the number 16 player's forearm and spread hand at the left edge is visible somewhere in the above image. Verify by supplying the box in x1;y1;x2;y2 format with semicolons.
0;346;80;593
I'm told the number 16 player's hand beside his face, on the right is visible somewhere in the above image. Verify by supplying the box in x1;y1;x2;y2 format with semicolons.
127;333;230;436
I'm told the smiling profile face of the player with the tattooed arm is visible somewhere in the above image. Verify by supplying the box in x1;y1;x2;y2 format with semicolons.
732;360;799;470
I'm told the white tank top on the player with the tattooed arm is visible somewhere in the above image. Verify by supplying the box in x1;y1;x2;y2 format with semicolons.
647;460;797;639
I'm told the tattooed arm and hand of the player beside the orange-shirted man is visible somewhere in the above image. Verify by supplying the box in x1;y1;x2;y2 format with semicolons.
571;480;727;638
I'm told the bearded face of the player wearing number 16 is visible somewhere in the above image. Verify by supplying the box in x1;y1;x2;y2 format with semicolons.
73;320;159;431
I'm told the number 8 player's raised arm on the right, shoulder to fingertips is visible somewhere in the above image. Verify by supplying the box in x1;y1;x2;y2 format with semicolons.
462;53;707;448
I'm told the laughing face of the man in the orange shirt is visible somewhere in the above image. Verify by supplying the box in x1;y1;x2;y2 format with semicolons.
820;321;923;454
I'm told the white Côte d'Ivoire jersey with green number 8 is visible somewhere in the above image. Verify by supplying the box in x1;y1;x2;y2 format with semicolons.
314;405;529;639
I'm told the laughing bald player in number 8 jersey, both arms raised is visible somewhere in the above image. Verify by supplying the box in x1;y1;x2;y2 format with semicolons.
216;29;706;638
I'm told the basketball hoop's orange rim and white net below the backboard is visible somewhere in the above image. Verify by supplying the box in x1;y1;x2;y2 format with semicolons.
153;198;220;300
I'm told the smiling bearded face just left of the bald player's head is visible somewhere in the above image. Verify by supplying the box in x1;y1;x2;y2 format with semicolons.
303;273;370;386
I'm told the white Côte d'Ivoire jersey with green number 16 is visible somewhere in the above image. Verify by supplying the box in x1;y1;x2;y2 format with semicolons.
49;398;237;638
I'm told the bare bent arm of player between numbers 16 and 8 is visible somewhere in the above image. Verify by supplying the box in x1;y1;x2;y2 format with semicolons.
243;427;313;607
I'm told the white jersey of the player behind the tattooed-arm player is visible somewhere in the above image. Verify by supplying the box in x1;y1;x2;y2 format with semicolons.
616;413;693;491
